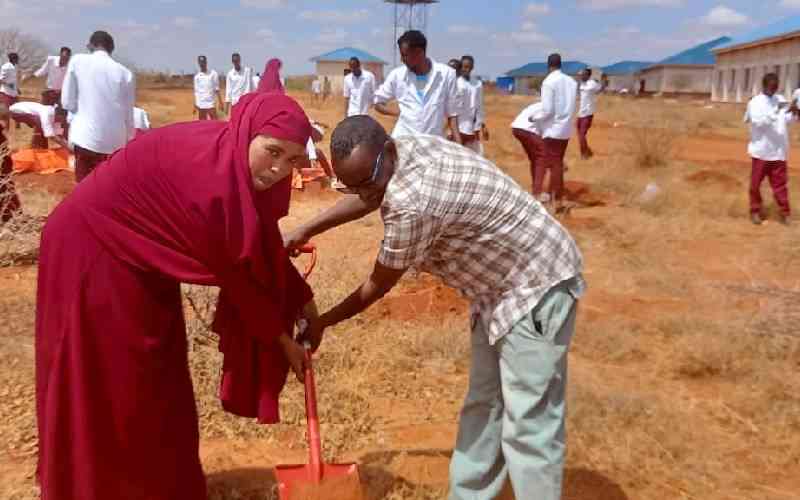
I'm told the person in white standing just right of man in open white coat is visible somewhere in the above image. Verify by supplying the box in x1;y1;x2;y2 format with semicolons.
456;56;489;156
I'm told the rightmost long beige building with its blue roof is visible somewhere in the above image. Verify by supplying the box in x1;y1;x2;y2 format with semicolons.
711;16;800;102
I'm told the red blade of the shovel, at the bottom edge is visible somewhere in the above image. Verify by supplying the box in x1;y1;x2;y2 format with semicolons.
275;464;364;500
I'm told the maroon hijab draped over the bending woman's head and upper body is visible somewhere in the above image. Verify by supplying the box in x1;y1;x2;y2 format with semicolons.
74;93;312;422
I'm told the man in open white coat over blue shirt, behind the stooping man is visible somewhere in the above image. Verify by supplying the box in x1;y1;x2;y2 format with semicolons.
375;30;462;144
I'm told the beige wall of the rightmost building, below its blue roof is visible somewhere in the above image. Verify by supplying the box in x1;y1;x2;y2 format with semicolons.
711;37;800;102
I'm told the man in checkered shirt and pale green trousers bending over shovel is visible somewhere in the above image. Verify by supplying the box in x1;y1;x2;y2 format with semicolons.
286;116;584;500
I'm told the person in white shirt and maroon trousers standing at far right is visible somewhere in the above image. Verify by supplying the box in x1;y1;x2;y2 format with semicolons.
744;73;798;225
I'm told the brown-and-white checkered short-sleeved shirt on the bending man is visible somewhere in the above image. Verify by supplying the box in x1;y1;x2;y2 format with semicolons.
378;135;585;344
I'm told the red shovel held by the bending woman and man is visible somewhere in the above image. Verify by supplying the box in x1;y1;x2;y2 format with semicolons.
275;244;363;500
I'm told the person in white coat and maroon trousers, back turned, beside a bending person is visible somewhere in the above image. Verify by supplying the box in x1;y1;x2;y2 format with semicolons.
529;54;578;212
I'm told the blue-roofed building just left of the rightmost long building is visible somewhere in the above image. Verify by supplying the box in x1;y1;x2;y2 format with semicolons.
637;36;731;94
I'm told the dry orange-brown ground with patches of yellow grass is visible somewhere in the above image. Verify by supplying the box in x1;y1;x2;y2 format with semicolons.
0;83;800;500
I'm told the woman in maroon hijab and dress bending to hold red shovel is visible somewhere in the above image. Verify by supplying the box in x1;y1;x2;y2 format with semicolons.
36;93;316;500
